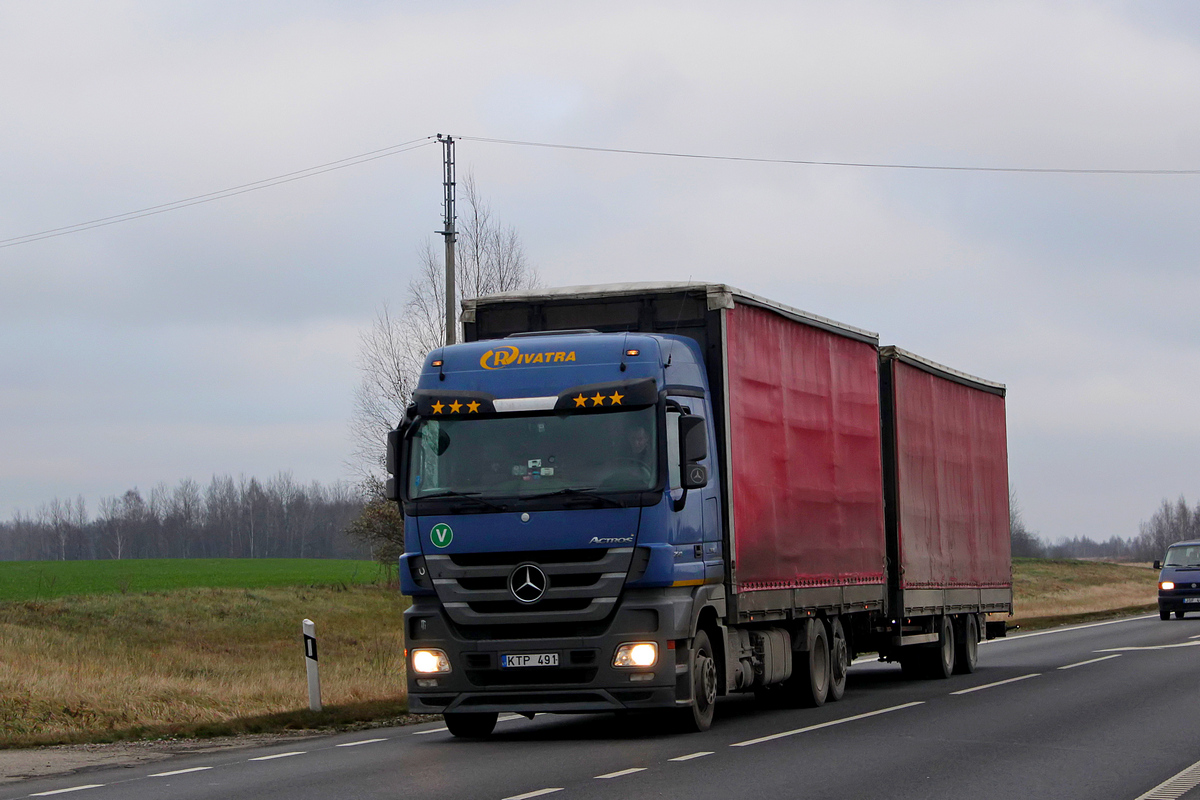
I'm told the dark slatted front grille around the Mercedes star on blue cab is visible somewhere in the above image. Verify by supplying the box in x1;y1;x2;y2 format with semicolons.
426;547;634;638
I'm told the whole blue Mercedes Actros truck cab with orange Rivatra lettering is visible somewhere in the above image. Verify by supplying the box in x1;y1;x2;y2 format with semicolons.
388;330;726;735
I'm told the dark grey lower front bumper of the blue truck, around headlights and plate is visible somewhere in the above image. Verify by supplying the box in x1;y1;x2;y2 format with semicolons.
404;588;696;714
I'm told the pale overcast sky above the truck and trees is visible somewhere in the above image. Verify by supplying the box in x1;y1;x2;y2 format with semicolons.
0;0;1200;540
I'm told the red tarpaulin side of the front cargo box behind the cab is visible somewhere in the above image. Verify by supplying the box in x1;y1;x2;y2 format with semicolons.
726;305;886;591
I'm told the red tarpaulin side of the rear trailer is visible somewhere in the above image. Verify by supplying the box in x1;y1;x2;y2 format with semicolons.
892;361;1013;589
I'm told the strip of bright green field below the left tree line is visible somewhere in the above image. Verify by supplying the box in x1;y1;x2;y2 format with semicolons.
0;559;385;602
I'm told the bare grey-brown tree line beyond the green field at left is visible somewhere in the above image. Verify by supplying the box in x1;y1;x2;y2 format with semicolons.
0;473;371;561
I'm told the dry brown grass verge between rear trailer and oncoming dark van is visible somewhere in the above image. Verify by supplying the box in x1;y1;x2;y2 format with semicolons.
1013;559;1158;622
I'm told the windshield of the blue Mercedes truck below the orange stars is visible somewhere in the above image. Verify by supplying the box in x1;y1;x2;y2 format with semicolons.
408;405;658;500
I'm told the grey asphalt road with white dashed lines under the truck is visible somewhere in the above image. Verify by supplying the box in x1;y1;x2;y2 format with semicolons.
9;615;1200;800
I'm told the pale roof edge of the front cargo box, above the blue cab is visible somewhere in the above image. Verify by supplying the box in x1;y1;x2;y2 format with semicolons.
462;282;880;345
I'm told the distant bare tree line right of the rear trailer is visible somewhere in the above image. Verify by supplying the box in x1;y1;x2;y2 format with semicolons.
1009;497;1200;561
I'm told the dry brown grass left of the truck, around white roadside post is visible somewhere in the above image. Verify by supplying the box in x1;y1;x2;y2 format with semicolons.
0;587;406;746
